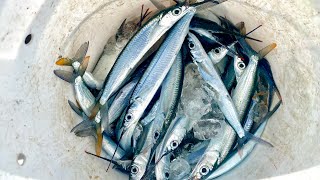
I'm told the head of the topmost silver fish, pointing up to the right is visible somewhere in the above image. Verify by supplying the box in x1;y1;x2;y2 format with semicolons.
159;5;196;29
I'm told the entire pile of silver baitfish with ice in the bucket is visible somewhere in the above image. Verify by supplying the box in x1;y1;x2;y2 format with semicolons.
54;1;282;179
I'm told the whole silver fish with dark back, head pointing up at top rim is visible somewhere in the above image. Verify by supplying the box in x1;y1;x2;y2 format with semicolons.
99;5;195;105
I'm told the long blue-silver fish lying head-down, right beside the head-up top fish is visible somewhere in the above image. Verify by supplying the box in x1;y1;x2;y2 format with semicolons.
120;10;195;152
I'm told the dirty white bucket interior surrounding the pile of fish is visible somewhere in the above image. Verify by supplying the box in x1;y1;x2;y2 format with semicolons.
0;0;320;179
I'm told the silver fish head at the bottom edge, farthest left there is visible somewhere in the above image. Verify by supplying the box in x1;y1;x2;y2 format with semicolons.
130;154;148;179
